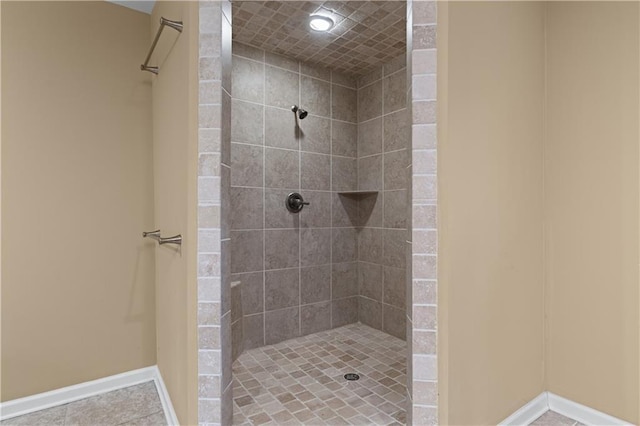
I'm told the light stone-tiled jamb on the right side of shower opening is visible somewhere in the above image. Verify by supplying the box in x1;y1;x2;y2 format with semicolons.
407;0;438;425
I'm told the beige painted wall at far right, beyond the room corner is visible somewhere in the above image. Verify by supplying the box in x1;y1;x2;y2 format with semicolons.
544;2;640;424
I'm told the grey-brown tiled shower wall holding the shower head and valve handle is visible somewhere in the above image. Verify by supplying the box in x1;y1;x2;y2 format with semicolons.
231;43;358;352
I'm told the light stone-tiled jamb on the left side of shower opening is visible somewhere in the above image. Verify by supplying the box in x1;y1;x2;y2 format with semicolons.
198;0;233;425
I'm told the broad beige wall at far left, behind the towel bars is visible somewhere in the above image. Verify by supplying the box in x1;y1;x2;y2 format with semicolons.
1;2;156;400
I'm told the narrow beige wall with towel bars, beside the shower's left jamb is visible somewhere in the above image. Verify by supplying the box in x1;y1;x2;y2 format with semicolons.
150;2;198;424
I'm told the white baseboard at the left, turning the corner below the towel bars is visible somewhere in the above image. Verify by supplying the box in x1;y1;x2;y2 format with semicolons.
0;365;178;426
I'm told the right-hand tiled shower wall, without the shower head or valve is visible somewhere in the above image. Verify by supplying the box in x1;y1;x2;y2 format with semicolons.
358;55;410;339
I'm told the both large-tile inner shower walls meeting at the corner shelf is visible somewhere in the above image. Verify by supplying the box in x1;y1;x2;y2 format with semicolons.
231;43;410;359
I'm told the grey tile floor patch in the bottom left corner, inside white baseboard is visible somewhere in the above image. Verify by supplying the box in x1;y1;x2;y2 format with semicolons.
0;382;167;426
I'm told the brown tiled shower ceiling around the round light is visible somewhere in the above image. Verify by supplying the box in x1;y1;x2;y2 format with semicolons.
232;0;406;76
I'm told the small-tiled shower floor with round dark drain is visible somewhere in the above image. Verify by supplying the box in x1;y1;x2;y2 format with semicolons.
233;324;407;425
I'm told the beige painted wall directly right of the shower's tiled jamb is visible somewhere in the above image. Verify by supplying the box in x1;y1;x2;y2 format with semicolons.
438;2;544;425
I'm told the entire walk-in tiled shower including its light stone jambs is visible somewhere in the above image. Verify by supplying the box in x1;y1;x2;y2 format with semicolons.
199;2;437;424
